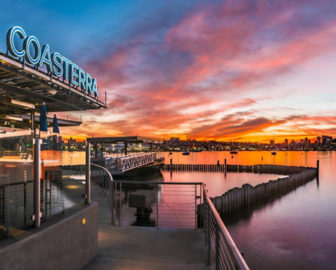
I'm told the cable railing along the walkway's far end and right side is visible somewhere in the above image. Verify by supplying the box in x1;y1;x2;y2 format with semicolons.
90;165;249;270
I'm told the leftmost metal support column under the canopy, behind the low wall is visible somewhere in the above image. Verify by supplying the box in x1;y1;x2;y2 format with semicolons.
34;135;41;228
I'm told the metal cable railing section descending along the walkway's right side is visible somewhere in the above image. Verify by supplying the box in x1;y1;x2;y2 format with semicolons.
203;186;249;270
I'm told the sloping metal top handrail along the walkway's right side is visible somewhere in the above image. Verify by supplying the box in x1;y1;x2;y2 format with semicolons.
203;184;250;270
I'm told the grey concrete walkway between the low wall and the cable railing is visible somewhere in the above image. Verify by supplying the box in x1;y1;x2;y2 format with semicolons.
84;184;210;270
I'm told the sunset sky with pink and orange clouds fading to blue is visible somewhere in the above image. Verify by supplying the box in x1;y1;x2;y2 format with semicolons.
0;0;336;141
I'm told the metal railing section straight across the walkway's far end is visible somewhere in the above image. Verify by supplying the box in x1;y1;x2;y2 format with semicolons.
109;181;202;229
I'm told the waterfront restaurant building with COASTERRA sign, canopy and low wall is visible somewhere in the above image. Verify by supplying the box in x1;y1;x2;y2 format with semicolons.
0;26;106;269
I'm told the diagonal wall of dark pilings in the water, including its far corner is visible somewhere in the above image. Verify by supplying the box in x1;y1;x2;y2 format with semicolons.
211;165;318;217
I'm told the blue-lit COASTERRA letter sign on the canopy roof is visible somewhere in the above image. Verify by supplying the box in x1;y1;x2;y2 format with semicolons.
7;26;98;97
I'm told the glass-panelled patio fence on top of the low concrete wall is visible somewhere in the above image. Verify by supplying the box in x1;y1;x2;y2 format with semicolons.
0;165;84;239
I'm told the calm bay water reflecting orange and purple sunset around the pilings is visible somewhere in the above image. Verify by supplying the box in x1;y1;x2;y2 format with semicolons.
39;151;336;269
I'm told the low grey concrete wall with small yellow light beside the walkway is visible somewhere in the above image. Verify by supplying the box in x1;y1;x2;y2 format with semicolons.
0;204;98;270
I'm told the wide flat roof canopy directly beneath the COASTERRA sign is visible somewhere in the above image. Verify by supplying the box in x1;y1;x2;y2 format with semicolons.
0;53;106;114
